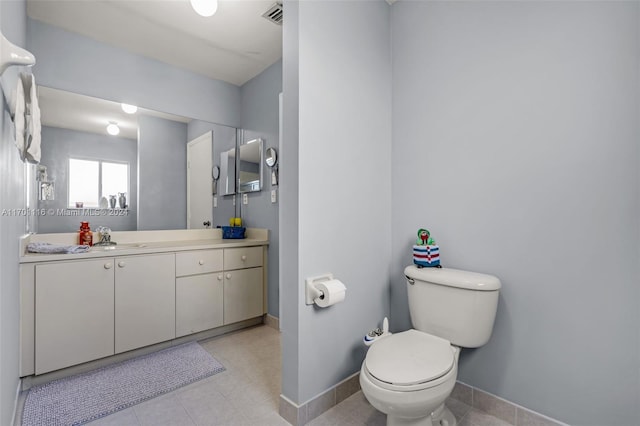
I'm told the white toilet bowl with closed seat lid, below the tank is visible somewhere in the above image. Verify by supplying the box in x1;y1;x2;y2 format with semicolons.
360;330;460;426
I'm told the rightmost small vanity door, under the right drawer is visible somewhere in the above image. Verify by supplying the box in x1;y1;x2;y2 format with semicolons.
224;267;264;324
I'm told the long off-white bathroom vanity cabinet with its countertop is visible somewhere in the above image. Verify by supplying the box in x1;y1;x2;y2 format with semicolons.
20;230;268;377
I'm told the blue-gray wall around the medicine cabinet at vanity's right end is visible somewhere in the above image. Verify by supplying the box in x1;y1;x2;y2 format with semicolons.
239;57;282;317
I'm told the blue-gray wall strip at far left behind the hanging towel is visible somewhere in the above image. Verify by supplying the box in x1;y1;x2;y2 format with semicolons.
0;0;27;425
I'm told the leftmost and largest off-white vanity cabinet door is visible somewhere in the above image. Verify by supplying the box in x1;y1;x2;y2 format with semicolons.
35;258;114;374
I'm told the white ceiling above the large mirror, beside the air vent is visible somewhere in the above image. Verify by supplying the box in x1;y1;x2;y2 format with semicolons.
27;0;282;86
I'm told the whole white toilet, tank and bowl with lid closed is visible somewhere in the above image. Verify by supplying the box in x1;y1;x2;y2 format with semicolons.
360;265;501;426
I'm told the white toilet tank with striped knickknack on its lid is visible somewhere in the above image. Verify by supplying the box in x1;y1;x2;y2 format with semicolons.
404;265;501;348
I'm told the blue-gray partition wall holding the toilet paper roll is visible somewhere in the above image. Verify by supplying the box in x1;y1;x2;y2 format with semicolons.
280;1;391;403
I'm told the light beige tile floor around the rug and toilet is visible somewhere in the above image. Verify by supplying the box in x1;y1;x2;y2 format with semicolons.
23;326;509;426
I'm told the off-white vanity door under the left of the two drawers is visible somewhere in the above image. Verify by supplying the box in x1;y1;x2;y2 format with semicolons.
176;272;224;337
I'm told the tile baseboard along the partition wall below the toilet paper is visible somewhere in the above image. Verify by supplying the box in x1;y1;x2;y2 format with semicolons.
279;371;360;426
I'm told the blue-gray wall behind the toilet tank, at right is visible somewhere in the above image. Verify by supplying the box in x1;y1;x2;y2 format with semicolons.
391;1;640;425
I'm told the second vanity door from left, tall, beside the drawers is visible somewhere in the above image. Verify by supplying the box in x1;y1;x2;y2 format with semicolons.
115;253;176;353
